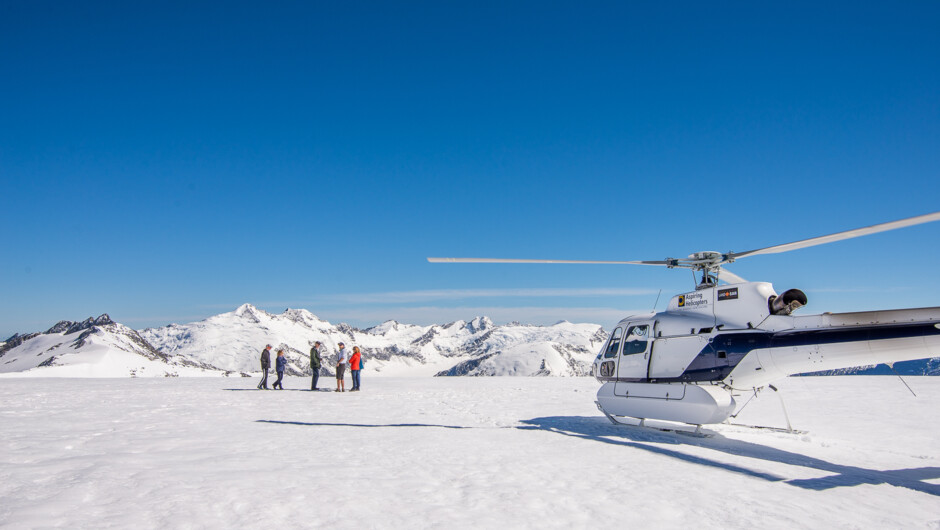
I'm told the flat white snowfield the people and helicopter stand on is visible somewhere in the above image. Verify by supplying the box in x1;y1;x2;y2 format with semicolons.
0;376;940;530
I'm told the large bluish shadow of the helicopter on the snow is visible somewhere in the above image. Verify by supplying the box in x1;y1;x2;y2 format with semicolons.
519;416;940;496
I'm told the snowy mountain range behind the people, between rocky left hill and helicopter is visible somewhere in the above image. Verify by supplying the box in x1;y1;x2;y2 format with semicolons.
141;304;607;376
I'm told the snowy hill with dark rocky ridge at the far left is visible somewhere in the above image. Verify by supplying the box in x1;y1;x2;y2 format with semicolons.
0;314;223;377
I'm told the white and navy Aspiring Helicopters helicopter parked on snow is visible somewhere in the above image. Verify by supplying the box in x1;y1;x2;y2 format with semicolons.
428;212;940;427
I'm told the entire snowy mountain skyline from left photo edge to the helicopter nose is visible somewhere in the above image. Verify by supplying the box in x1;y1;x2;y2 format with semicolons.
0;304;607;377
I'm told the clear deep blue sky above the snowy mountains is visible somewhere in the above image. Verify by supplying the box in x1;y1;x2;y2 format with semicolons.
0;1;940;339
